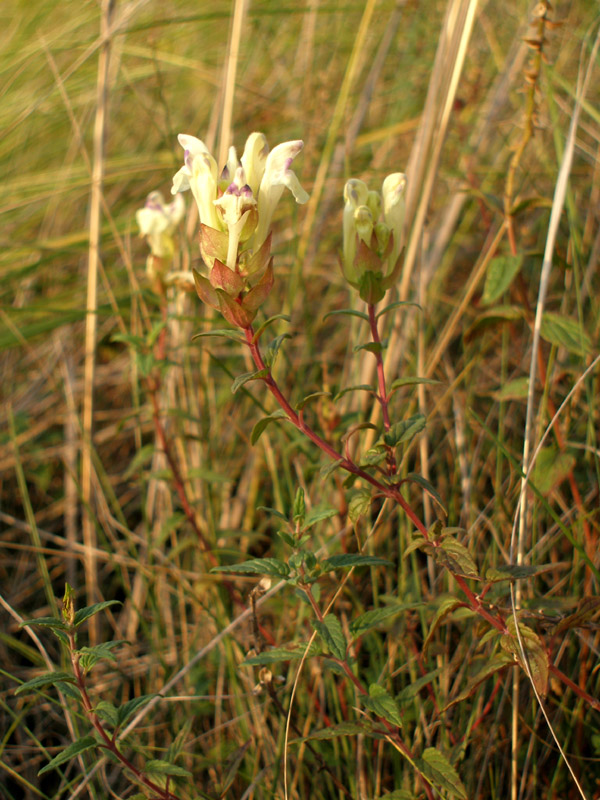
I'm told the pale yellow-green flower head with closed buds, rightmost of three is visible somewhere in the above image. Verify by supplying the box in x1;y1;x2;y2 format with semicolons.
342;172;406;303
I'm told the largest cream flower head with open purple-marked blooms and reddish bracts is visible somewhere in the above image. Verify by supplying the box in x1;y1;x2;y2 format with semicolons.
171;133;308;327
